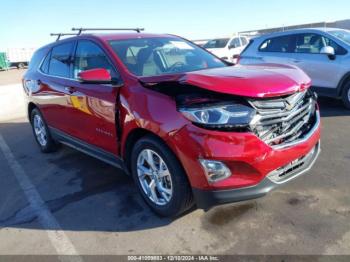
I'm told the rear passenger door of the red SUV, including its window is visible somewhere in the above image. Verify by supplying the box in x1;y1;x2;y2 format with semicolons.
33;41;75;133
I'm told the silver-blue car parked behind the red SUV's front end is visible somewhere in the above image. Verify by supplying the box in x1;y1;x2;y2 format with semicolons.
239;28;350;109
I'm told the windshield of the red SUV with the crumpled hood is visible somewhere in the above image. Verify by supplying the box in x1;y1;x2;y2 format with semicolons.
109;38;226;76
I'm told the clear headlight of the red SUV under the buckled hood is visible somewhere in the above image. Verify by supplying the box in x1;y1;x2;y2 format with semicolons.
180;104;255;128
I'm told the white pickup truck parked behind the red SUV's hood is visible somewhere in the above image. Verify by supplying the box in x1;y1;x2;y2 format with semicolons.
203;35;249;64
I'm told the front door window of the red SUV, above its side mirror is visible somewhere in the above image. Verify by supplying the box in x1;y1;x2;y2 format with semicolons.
74;40;119;79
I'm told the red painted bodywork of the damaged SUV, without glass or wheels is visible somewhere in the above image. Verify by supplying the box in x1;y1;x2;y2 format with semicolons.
24;34;320;196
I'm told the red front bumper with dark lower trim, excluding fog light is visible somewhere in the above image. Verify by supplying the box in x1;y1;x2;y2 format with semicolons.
171;111;321;209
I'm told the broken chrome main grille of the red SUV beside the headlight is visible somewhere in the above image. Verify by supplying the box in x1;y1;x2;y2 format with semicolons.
249;91;316;147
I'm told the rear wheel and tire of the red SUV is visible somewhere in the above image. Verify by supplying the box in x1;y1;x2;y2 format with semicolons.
30;108;57;153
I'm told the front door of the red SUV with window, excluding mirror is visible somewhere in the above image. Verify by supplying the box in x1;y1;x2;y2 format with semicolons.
69;40;122;154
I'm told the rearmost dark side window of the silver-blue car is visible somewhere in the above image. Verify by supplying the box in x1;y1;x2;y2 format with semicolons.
259;35;296;53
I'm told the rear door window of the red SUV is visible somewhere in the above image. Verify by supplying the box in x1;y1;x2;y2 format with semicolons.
48;42;74;78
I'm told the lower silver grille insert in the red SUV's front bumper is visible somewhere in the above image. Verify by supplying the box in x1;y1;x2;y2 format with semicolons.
267;143;320;184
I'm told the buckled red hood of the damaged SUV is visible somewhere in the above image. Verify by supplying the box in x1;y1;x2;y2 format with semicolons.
139;64;311;98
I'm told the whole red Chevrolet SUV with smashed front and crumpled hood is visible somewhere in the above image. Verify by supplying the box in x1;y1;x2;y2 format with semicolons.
23;29;320;216
